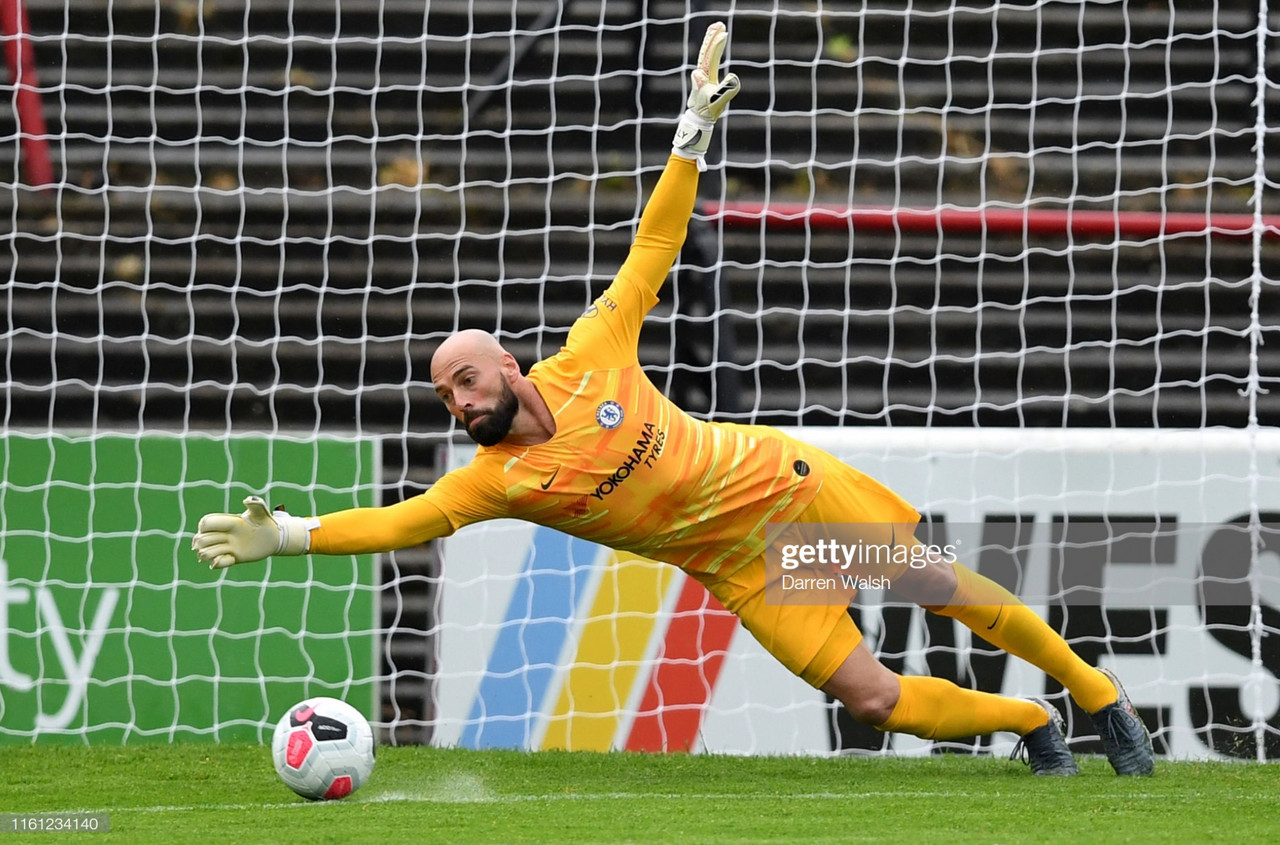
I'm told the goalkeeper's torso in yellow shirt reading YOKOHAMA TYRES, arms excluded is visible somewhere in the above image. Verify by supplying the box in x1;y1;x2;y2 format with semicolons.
481;355;817;562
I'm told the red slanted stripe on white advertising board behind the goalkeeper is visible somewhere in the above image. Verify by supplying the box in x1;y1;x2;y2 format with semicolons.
627;577;737;752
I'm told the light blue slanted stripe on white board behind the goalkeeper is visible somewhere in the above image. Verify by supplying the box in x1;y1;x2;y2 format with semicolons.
460;526;599;749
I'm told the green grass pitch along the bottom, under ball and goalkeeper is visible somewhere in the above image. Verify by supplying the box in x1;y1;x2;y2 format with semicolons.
0;744;1280;845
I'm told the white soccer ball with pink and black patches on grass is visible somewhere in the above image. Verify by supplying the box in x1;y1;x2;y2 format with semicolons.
271;696;374;800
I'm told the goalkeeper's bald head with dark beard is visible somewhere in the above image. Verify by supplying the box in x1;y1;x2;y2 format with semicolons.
431;329;520;446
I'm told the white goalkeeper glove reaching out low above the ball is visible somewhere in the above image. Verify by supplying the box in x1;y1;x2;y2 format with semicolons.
191;495;320;570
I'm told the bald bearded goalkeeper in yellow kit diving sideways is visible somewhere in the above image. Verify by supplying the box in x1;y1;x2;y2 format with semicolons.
192;23;1153;775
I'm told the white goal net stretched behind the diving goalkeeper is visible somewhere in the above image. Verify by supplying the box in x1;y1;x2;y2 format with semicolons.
0;0;1280;759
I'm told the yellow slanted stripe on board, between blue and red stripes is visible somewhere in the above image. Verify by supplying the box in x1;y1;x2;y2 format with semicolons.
543;552;676;752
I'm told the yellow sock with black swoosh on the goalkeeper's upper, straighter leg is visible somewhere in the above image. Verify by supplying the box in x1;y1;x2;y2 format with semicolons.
931;563;1116;713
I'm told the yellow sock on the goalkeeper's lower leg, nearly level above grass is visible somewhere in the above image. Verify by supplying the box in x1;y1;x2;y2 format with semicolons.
876;676;1048;740
